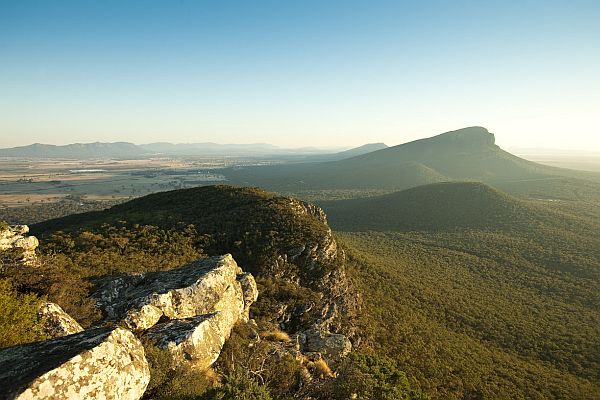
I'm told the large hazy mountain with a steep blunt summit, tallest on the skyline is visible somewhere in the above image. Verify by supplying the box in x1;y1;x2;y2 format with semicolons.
224;127;597;191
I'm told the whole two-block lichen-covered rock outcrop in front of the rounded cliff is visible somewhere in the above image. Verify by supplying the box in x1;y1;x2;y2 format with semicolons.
93;254;258;369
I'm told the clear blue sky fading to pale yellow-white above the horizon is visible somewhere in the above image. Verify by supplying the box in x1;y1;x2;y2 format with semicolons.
0;0;600;150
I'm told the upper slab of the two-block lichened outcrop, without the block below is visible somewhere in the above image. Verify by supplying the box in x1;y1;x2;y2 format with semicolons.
92;254;258;331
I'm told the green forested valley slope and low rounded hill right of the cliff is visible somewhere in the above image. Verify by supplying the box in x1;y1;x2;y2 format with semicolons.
321;182;600;399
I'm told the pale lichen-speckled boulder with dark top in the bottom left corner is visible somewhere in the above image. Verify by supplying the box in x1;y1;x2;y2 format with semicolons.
0;328;150;400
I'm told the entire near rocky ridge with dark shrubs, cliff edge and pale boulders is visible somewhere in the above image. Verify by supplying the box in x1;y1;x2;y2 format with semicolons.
0;186;370;400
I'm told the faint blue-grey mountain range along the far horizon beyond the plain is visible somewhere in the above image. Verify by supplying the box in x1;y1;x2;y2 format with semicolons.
0;142;387;161
